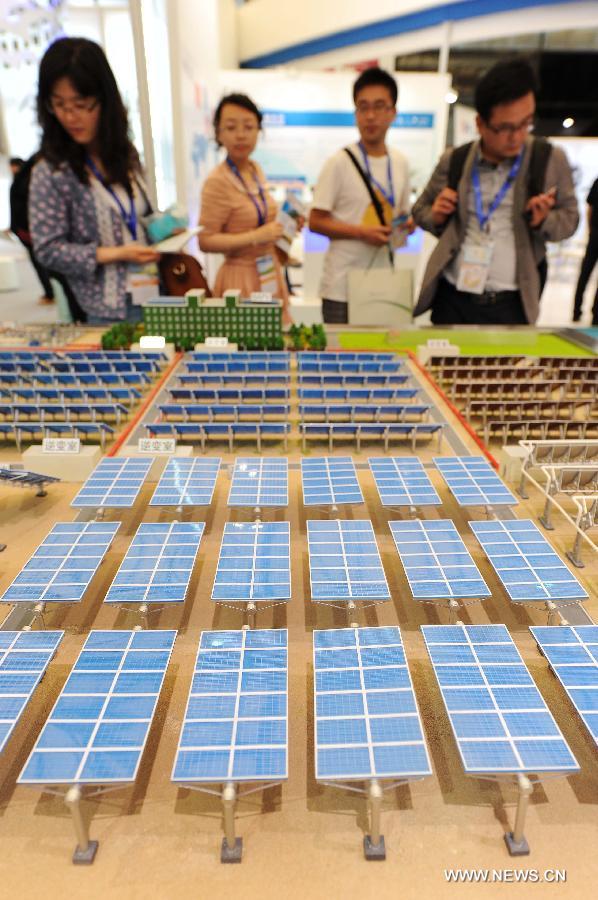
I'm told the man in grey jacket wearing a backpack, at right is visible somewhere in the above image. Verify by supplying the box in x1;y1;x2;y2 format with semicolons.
413;60;578;325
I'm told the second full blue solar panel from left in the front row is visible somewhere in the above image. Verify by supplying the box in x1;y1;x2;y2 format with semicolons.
172;628;288;784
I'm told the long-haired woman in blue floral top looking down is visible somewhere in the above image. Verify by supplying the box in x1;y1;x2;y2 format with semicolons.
29;38;159;324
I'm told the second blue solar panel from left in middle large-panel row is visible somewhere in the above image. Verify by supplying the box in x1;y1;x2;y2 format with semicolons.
104;522;205;603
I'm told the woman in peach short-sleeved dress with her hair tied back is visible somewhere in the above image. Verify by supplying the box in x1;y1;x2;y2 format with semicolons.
199;94;288;322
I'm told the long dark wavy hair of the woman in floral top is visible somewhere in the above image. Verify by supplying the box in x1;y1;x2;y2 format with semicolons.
37;38;140;193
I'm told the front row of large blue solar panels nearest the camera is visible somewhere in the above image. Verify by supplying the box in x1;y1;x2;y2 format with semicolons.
0;625;598;785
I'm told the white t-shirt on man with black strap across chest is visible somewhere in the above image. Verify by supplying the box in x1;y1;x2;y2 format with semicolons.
312;144;409;302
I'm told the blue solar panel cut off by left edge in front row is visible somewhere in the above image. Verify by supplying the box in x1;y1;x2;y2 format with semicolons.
0;631;64;753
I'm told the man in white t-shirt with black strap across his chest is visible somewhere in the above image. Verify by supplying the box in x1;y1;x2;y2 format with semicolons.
309;67;411;324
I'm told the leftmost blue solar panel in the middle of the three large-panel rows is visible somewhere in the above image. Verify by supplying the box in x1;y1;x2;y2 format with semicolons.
0;522;120;603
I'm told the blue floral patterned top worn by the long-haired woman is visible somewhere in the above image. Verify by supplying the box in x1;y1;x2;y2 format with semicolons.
29;159;151;319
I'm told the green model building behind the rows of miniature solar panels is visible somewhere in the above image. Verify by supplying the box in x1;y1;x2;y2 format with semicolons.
143;290;284;350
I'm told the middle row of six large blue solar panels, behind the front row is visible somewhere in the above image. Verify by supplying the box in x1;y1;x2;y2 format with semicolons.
0;512;587;604
